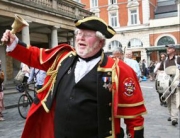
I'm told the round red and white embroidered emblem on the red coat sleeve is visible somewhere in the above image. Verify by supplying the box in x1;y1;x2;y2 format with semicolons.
123;78;135;96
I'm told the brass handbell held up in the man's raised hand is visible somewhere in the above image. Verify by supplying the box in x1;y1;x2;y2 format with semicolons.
2;14;29;45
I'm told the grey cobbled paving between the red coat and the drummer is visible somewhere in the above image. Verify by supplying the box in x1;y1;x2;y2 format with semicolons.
141;81;180;138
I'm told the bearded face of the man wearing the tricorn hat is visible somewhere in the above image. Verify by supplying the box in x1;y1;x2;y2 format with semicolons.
75;29;104;58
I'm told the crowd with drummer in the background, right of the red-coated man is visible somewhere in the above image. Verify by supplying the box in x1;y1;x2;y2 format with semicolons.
112;44;180;126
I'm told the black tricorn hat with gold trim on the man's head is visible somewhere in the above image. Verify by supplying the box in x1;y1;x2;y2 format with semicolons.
74;16;116;38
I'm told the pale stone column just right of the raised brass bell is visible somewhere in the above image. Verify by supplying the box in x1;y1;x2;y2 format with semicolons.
22;26;30;45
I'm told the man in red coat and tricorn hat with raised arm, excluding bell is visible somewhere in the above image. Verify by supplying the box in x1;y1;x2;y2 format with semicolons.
1;16;146;138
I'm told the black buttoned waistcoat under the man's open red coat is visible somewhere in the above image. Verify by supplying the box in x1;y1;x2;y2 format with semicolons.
54;61;98;138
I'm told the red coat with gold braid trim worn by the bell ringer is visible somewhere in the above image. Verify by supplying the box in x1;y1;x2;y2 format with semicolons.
8;44;146;138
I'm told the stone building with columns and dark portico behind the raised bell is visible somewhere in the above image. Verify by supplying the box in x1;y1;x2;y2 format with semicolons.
0;0;92;83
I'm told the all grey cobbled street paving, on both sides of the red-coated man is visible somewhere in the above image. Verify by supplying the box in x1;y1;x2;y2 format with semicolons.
0;81;180;138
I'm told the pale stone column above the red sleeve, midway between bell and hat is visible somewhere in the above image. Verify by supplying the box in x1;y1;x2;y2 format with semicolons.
50;26;59;48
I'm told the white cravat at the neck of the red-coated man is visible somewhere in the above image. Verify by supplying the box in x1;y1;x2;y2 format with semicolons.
74;57;101;83
